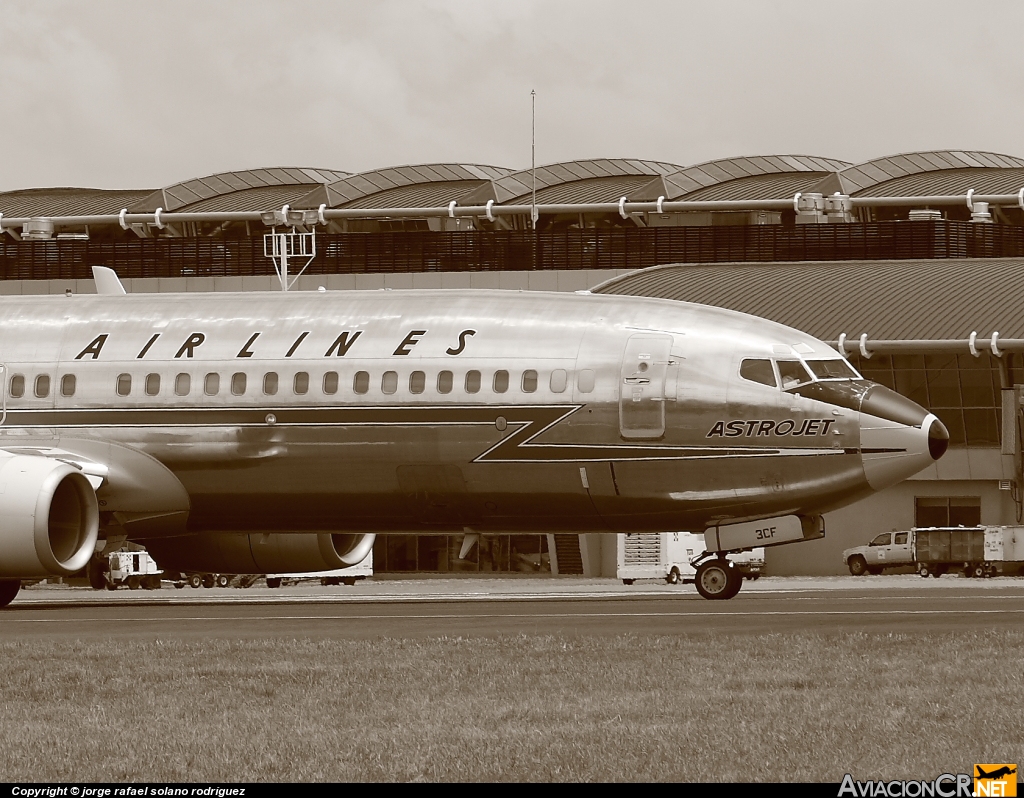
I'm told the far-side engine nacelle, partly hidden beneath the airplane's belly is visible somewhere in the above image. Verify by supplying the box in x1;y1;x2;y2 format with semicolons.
146;532;376;574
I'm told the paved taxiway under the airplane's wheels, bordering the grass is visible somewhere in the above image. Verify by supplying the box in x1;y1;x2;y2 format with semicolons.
0;576;1024;640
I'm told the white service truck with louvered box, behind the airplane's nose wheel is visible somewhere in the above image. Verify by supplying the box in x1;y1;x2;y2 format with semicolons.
615;532;765;585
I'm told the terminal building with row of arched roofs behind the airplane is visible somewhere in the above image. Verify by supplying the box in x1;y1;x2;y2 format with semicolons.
0;151;1024;576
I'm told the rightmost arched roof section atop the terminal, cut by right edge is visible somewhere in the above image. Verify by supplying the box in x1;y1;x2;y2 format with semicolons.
827;150;1024;197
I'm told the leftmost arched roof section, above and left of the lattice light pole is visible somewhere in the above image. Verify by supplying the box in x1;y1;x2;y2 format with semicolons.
128;167;349;213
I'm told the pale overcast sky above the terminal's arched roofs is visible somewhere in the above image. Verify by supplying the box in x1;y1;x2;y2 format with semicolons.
0;0;1024;191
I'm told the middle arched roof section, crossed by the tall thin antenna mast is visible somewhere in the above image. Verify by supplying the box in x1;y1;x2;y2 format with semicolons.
465;158;680;204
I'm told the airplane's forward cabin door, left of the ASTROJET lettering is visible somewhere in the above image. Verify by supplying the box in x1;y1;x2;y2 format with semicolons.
618;335;672;440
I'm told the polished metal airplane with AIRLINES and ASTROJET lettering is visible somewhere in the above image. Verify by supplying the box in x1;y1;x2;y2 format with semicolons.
0;267;949;605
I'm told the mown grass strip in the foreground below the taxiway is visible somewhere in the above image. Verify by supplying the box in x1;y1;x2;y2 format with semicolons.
0;632;1024;782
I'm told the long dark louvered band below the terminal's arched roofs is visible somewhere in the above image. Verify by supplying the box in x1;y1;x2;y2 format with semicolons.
0;221;1024;280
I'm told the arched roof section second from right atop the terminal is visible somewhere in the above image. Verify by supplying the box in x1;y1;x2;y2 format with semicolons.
630;155;850;201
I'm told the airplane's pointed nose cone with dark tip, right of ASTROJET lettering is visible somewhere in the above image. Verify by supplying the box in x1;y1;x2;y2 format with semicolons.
860;385;949;491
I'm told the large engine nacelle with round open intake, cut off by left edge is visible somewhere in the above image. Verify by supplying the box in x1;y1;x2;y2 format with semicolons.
0;453;99;579
